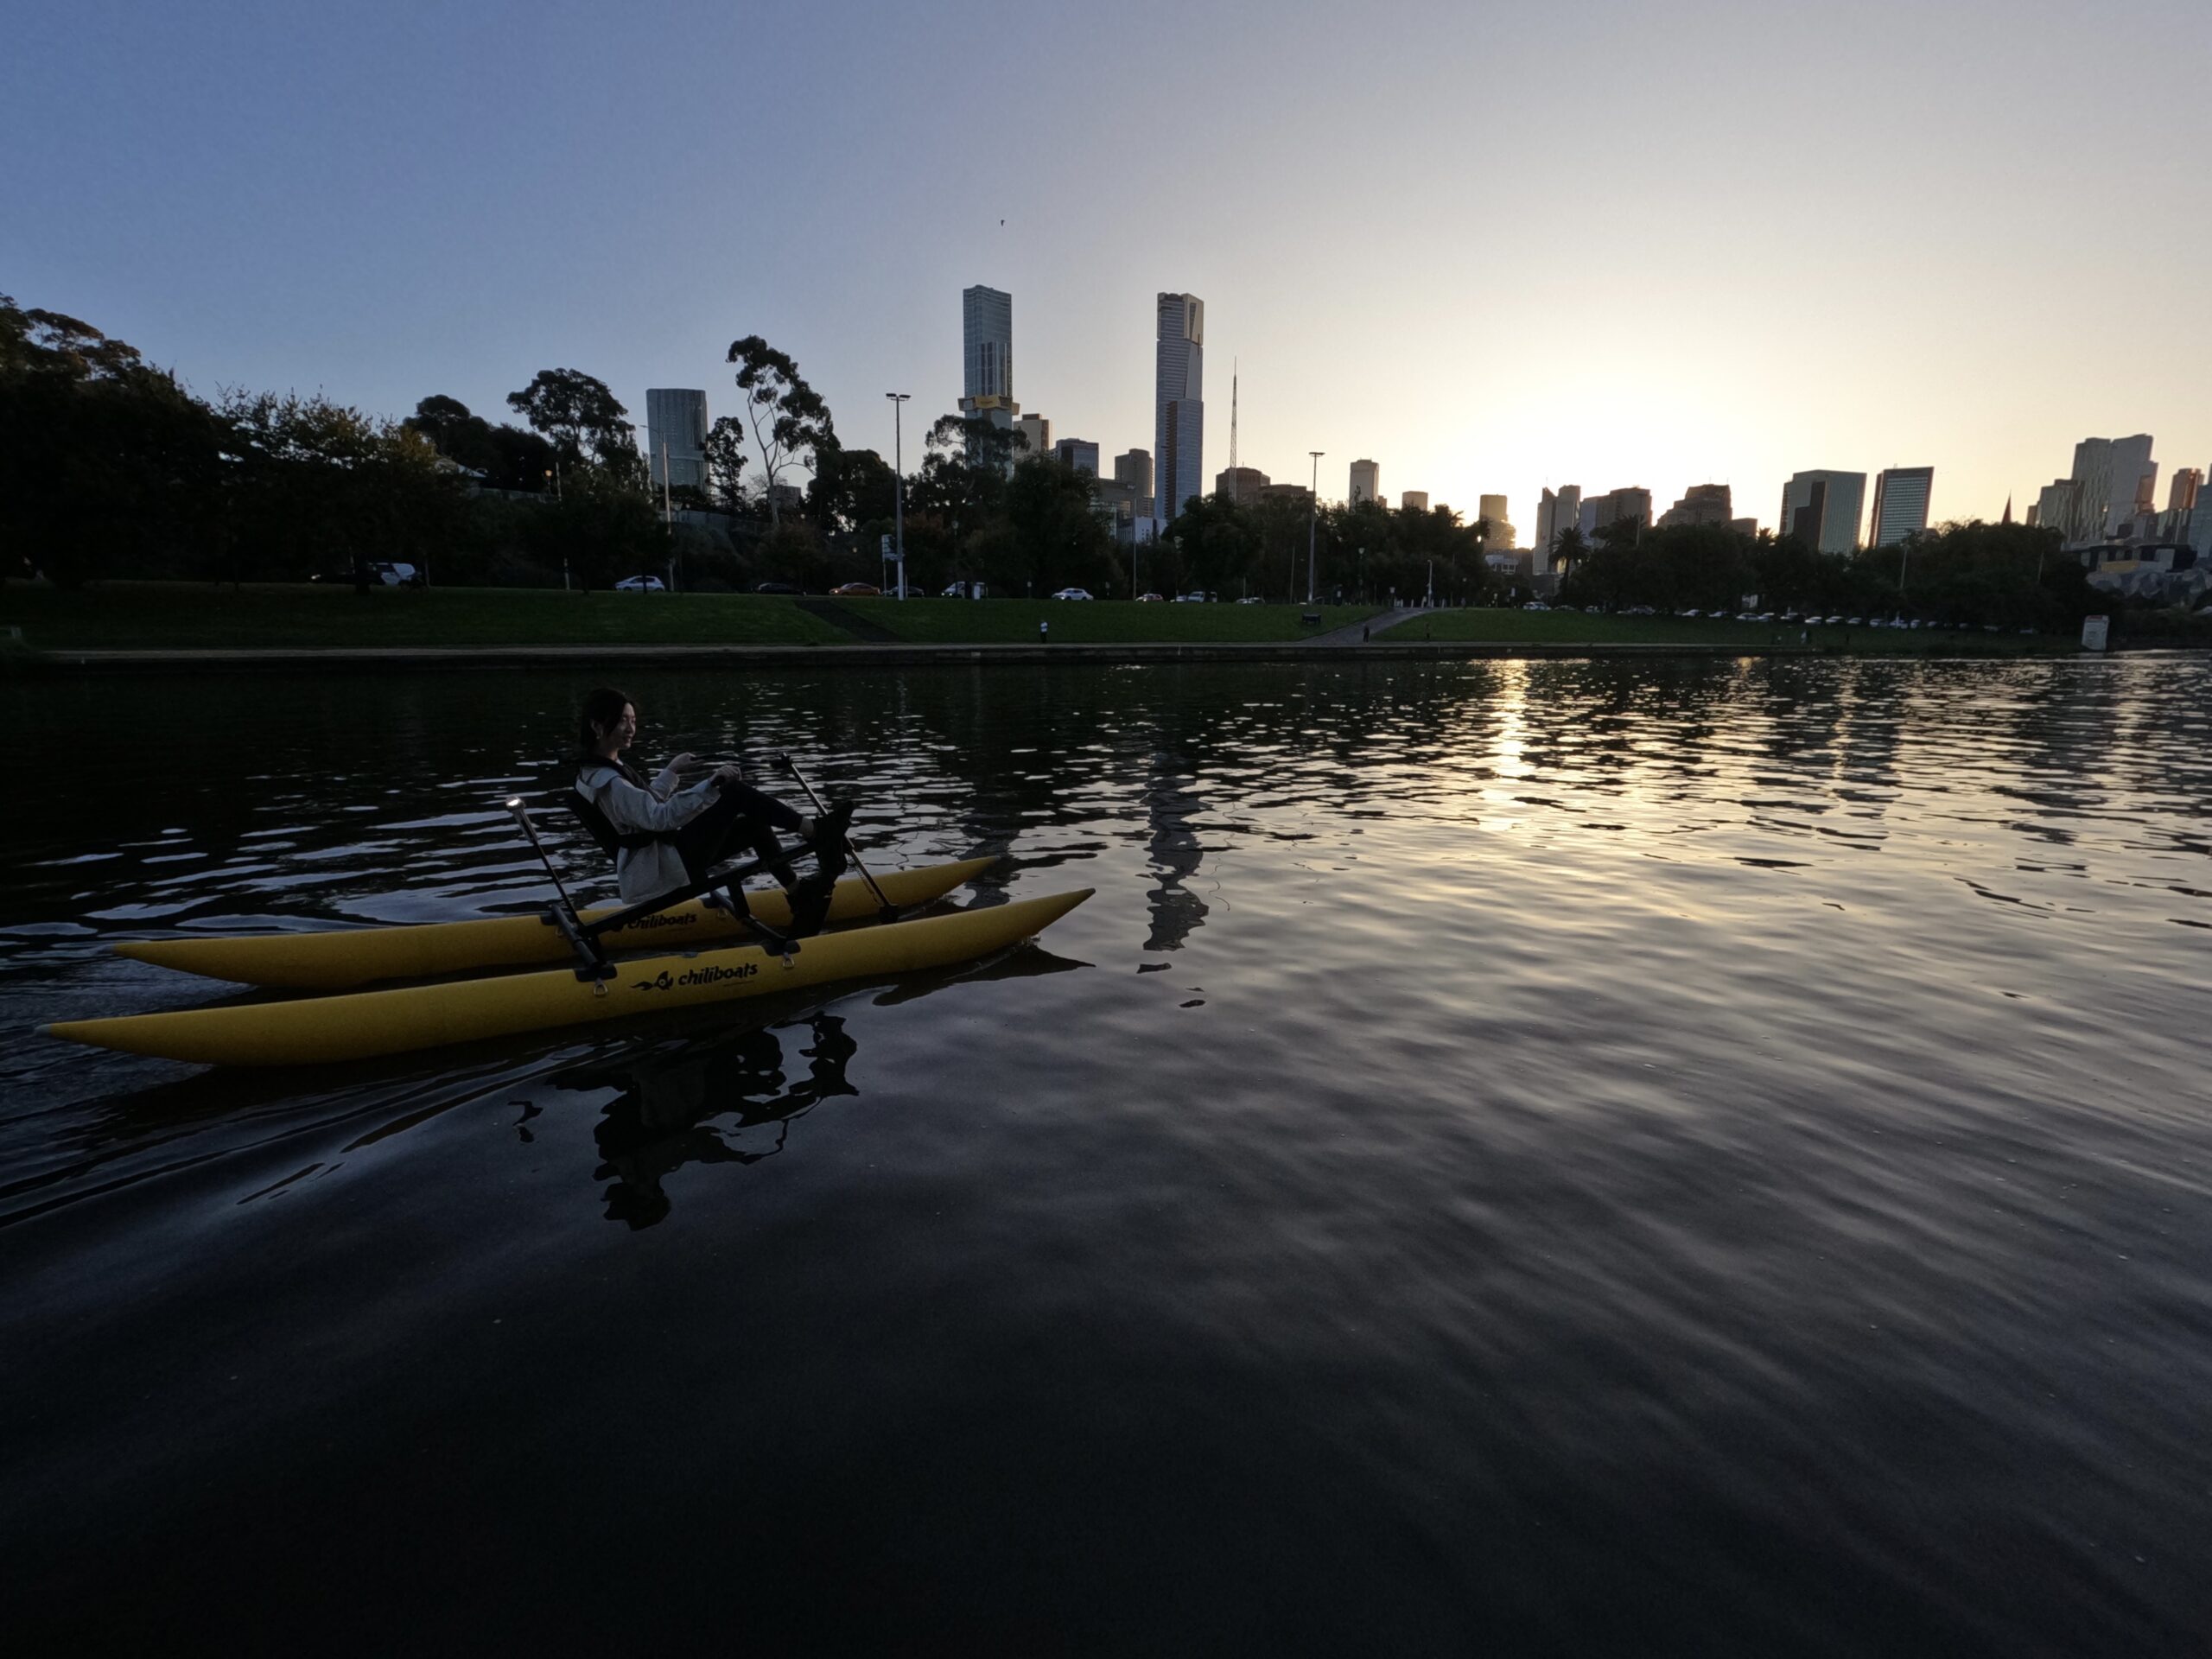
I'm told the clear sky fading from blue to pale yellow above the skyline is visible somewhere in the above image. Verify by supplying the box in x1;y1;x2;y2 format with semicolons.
0;0;2212;532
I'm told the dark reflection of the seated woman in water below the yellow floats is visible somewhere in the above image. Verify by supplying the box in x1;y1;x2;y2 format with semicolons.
556;1013;861;1228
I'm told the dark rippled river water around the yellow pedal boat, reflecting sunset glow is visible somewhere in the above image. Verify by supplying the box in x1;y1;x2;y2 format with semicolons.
0;657;2212;1655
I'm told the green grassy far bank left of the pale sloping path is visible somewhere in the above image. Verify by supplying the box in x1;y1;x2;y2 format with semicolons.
0;582;1374;651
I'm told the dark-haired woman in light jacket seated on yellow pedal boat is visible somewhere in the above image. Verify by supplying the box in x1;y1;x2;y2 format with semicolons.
575;686;852;936
